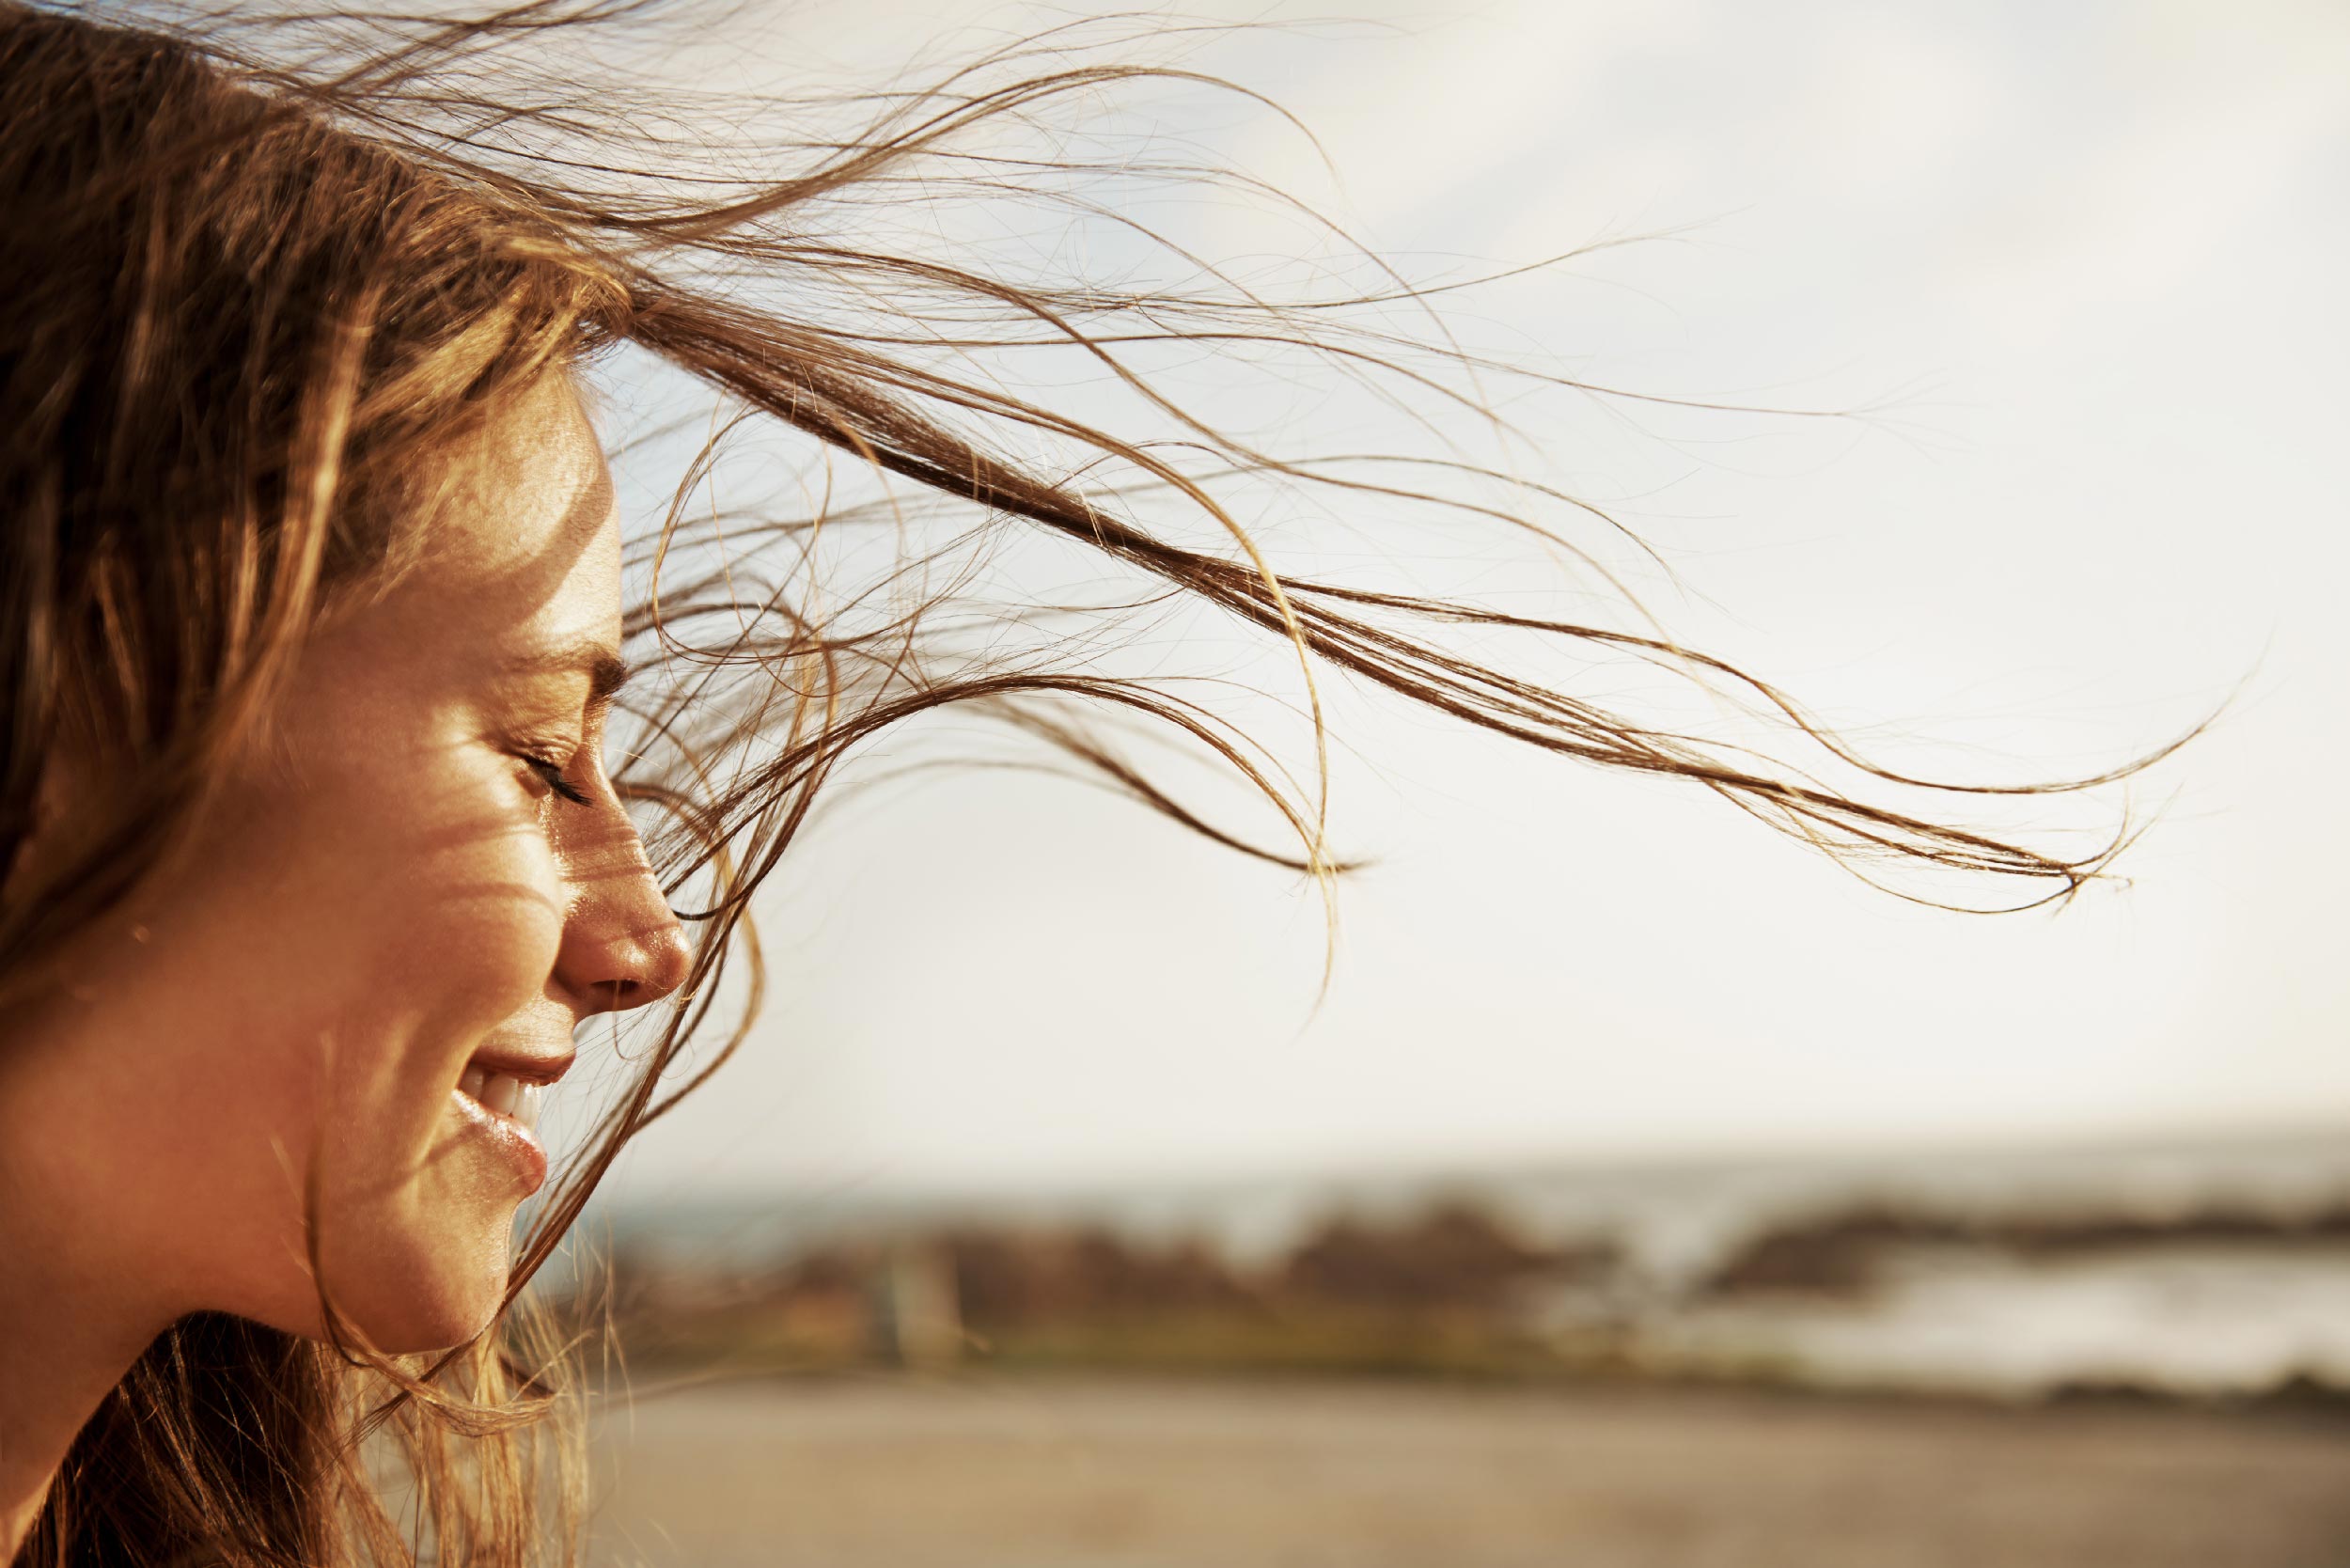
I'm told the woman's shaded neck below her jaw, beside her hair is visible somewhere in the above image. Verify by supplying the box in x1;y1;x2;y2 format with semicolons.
0;1175;169;1563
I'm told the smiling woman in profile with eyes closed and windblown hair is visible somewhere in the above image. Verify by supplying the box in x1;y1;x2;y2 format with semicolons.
0;0;2162;1565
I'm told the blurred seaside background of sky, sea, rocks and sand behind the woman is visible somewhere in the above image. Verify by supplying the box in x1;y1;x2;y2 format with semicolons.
540;0;2350;1568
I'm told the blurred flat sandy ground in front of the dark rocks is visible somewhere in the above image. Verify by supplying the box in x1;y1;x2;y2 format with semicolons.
592;1382;2350;1568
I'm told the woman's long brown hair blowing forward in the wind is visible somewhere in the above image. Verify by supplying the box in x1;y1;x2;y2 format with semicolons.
0;0;2171;1568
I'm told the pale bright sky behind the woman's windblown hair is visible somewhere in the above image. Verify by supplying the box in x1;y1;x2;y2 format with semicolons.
583;0;2350;1197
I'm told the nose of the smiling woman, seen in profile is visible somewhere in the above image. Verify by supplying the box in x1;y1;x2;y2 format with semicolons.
555;811;694;1018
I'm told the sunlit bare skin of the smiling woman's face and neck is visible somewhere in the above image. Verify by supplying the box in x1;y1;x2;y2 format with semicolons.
0;381;689;1559
